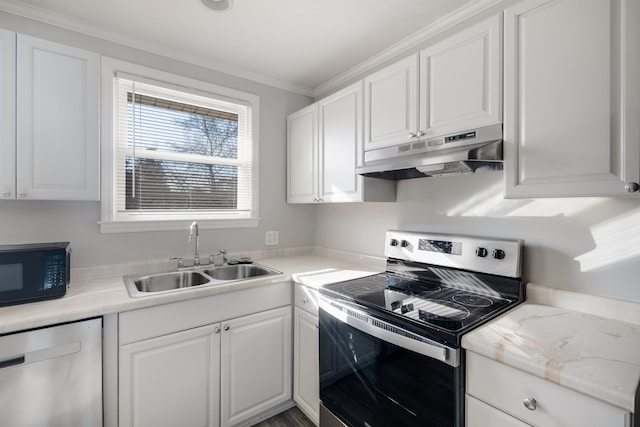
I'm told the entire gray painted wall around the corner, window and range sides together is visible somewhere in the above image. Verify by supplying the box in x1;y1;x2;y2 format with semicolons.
0;12;640;308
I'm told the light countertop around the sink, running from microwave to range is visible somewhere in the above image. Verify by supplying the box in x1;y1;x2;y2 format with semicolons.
0;247;385;334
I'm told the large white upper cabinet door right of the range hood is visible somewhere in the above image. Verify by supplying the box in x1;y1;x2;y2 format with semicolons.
505;0;640;197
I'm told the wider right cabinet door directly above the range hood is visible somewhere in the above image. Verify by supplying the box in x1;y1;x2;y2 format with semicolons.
420;15;502;138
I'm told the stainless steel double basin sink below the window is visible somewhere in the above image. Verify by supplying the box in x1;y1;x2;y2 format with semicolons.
124;264;282;297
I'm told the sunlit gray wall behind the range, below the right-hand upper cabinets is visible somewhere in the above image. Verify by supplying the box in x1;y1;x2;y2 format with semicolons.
315;172;640;302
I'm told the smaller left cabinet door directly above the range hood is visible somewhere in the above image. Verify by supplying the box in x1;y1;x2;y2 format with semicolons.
364;55;418;151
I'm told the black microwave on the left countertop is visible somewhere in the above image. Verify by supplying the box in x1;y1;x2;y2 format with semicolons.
0;242;71;306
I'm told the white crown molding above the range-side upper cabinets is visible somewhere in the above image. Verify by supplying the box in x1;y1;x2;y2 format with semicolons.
313;0;504;99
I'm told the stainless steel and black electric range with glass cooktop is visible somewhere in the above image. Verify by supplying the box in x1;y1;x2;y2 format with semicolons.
319;231;524;427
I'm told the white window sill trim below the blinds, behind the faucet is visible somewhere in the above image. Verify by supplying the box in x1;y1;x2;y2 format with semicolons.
98;218;259;234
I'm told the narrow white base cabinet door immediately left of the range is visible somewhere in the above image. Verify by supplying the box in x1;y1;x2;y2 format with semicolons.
293;307;320;424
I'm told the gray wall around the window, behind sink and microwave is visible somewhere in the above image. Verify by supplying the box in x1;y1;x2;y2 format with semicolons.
0;12;315;267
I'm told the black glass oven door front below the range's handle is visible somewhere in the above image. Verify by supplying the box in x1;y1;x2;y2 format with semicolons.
320;310;462;427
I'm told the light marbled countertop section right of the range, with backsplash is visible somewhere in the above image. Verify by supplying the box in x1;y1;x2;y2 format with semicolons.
462;284;640;412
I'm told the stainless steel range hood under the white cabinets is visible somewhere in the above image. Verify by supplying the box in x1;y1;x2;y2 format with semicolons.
356;124;502;180
